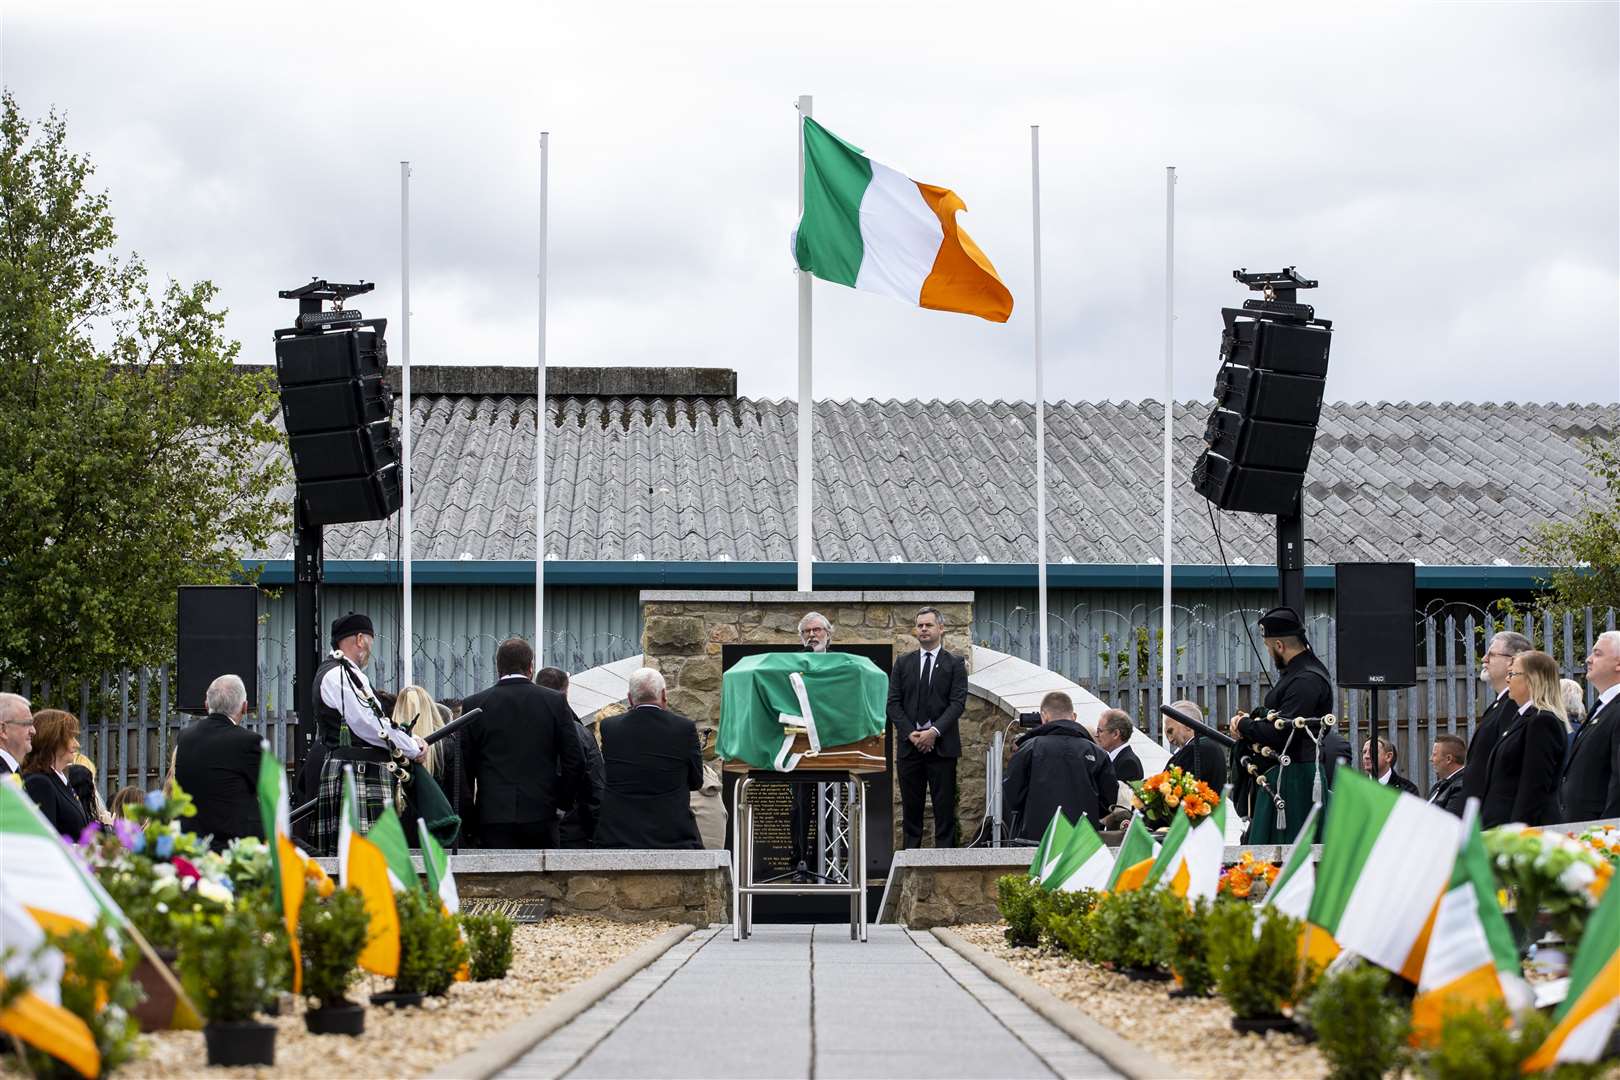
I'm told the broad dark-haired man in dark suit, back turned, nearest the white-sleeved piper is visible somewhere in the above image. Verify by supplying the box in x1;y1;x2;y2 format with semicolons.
462;638;590;848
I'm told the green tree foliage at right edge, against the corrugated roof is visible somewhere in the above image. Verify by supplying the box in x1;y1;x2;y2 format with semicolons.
1523;436;1620;609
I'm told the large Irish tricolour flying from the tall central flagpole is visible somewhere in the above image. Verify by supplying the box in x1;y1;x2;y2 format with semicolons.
794;117;1013;322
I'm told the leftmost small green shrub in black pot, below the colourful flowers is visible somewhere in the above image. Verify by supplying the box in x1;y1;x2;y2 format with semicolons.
180;908;275;1065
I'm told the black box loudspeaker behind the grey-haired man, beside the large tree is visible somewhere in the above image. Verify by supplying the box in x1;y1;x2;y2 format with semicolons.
175;585;259;714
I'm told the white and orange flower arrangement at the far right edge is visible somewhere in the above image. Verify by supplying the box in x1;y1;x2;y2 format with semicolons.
1486;824;1615;949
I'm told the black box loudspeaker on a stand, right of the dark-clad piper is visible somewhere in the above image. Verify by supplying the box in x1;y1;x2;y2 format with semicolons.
1333;562;1418;690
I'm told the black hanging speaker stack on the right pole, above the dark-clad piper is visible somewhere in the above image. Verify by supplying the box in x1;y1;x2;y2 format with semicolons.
1192;301;1333;515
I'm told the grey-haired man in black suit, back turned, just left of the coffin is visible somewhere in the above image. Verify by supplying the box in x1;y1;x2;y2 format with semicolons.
596;667;703;848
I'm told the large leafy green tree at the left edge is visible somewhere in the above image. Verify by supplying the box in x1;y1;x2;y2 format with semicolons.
0;92;288;685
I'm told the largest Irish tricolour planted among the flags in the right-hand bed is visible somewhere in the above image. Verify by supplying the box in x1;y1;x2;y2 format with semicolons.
1307;769;1461;983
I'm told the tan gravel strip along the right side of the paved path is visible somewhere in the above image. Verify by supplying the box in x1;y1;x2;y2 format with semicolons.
953;925;1327;1080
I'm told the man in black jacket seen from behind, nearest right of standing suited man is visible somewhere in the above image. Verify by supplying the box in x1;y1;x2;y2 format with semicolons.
1001;705;1118;840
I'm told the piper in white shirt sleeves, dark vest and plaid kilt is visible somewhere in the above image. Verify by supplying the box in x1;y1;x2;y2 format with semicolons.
303;612;428;855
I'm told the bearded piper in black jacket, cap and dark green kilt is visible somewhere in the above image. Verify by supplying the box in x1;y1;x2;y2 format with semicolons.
1230;607;1343;844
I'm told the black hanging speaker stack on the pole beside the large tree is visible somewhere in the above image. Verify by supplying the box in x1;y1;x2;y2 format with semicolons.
275;319;403;525
